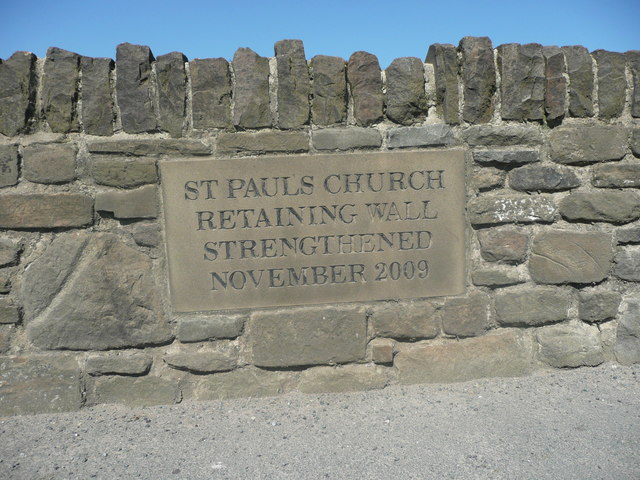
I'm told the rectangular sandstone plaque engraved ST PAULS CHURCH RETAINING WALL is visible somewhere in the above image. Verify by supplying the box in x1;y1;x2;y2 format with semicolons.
160;150;465;312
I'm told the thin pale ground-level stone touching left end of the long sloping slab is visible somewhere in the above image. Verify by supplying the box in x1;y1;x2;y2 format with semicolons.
298;365;387;393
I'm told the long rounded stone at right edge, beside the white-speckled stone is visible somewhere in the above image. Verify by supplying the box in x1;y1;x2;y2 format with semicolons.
559;191;640;223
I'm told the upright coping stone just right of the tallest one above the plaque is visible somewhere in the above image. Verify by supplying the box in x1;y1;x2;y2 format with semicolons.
309;55;347;125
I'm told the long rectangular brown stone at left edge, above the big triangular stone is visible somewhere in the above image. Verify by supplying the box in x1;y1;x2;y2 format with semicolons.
0;193;93;230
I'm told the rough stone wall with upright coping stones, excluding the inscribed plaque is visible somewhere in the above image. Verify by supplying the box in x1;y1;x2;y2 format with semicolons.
0;37;640;415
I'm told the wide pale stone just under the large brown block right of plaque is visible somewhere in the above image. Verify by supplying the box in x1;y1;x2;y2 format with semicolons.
496;287;570;327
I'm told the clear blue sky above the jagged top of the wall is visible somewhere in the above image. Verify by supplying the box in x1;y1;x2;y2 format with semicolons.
0;0;640;68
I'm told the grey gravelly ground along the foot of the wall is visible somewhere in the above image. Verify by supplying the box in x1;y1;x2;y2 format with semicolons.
0;365;640;480
